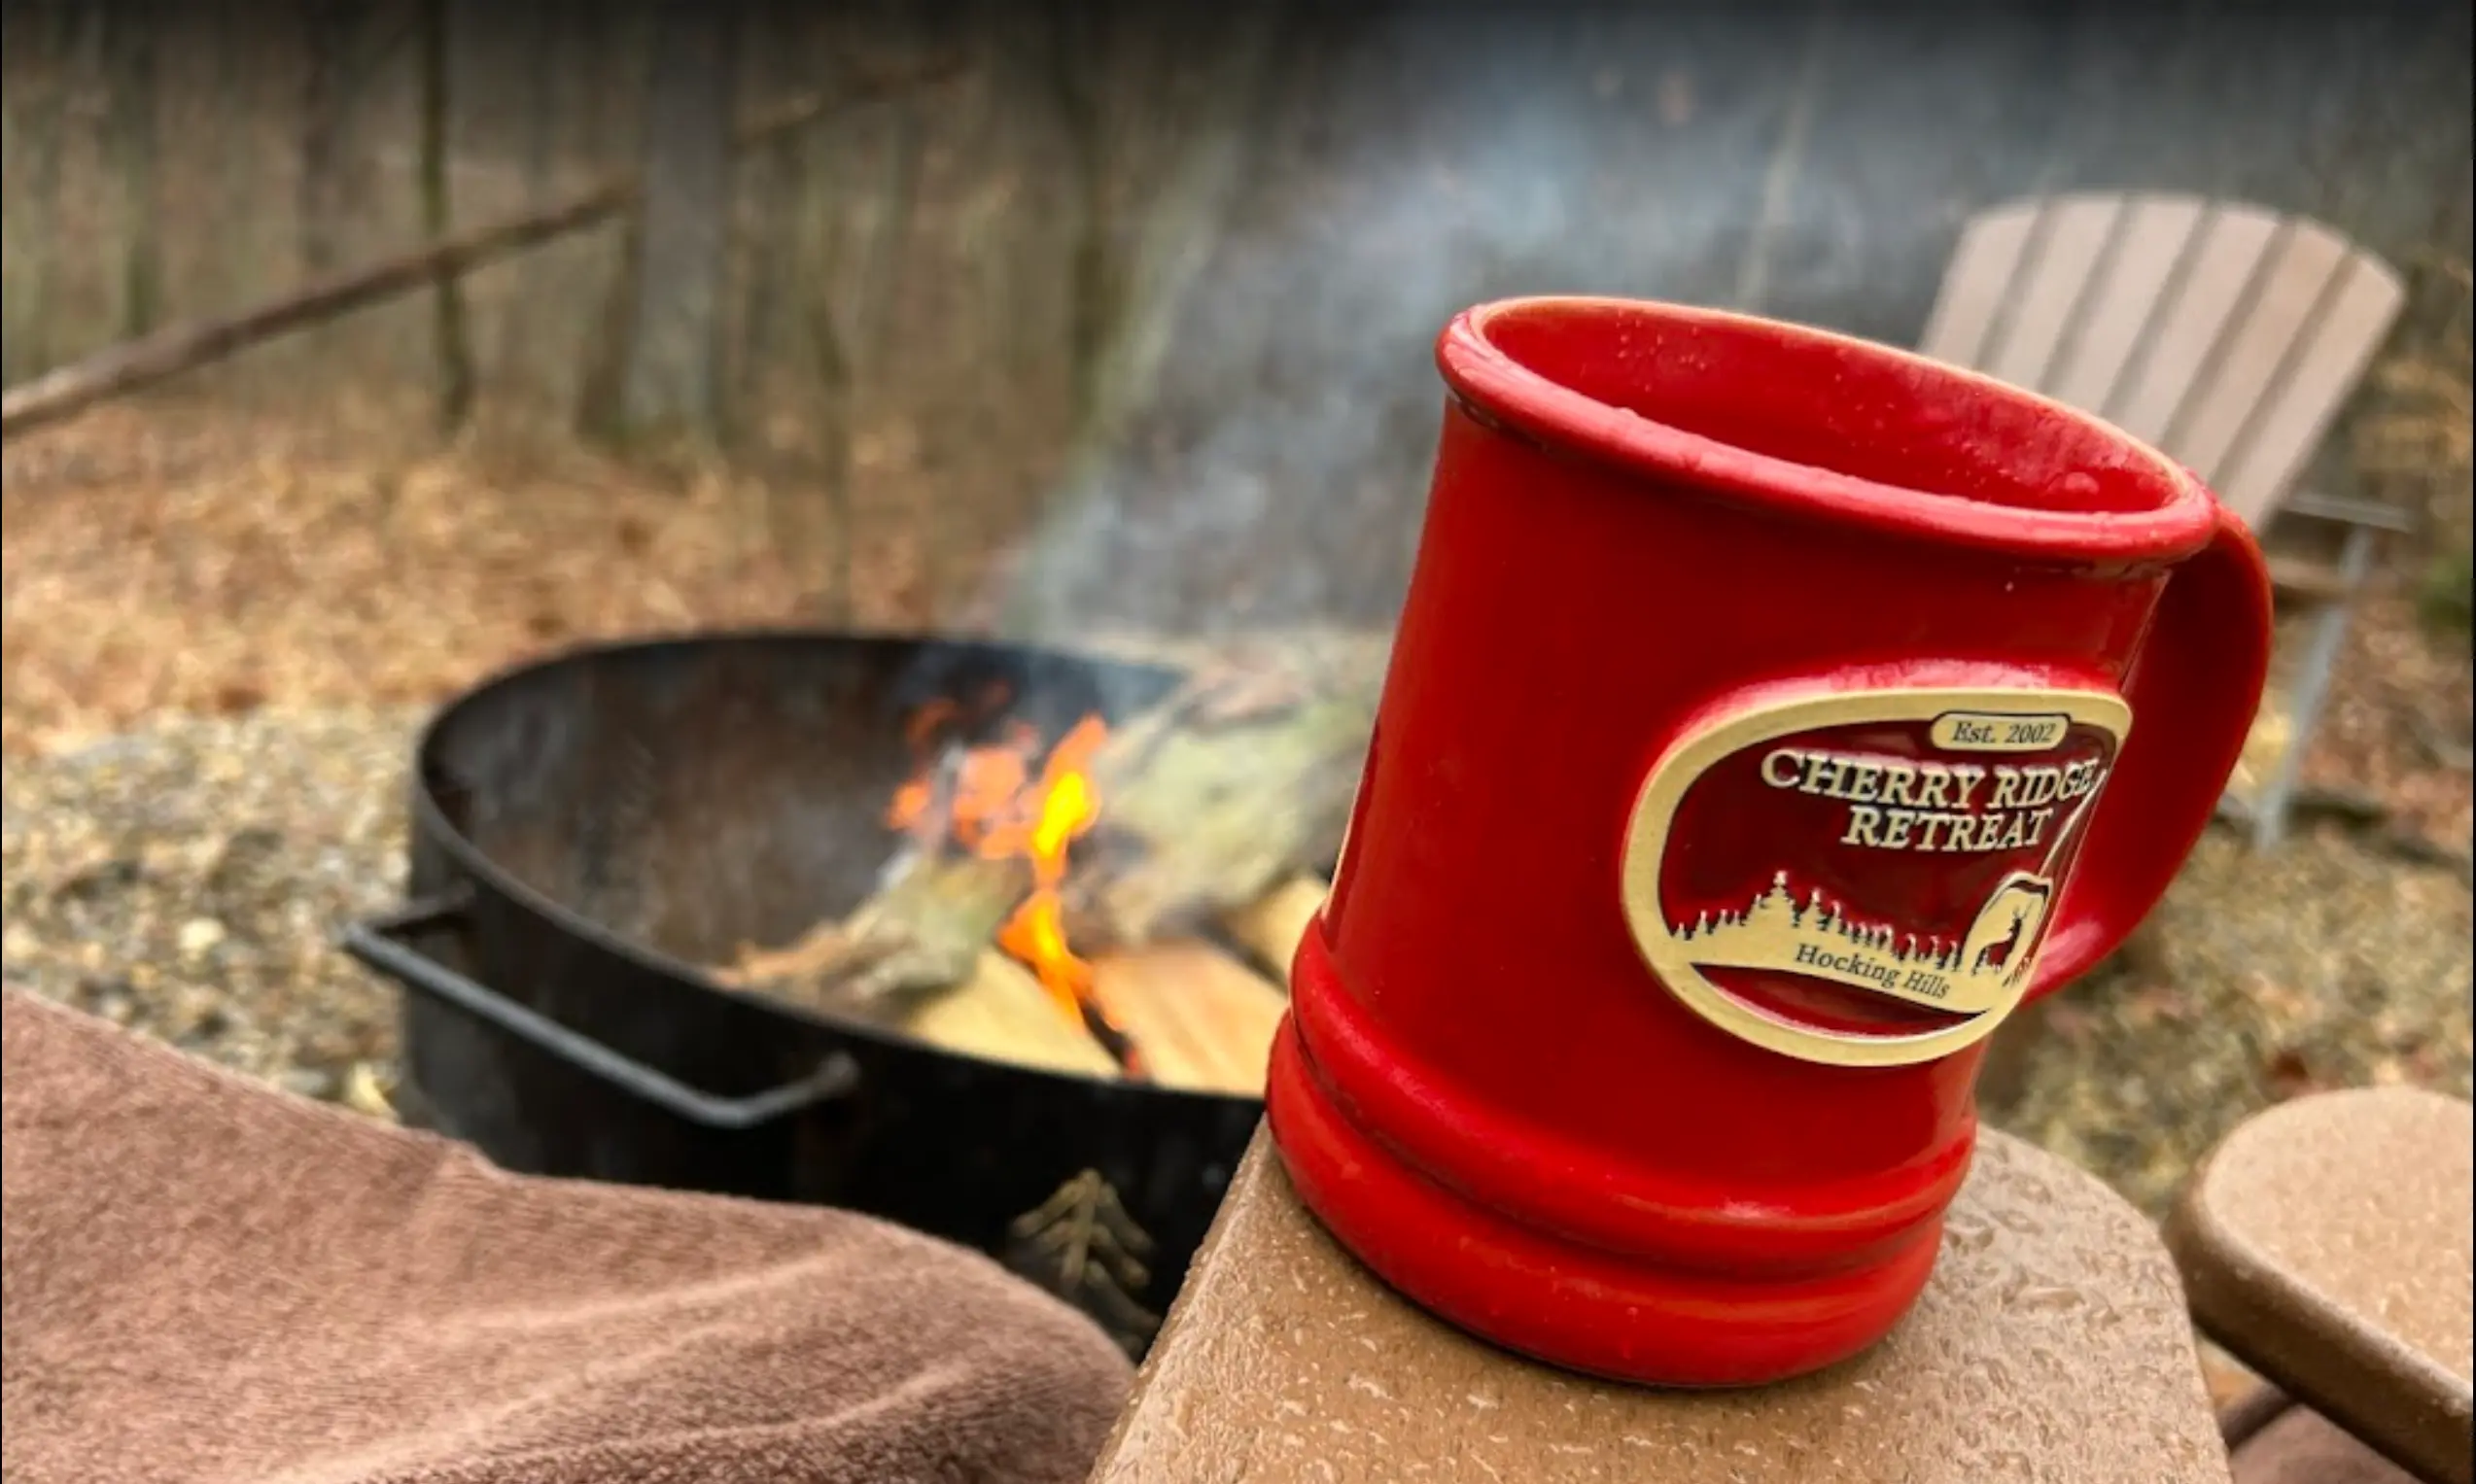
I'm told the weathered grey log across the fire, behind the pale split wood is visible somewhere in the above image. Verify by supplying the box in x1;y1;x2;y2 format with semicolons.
723;630;1384;1021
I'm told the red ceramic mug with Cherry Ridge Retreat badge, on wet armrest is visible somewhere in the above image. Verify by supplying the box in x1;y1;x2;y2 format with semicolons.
1268;299;2271;1385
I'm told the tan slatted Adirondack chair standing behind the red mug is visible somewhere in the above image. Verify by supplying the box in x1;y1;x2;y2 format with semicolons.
1919;193;2412;848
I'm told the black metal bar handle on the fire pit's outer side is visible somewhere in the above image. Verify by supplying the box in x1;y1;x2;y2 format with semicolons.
339;895;859;1130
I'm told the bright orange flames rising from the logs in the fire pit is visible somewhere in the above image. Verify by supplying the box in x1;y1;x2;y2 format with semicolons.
887;707;1133;1068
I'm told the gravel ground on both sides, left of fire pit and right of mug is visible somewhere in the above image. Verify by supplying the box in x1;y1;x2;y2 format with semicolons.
0;707;2476;1215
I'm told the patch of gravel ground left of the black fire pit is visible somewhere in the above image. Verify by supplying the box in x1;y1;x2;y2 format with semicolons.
0;707;421;1111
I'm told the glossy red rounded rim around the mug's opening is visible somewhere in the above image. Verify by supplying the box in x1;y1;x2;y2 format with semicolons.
1436;294;2218;562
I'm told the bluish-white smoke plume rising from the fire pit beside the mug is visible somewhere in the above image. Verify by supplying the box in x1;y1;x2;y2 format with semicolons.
1003;15;1663;634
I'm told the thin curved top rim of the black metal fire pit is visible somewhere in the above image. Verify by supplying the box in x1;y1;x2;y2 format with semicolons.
411;626;1263;1106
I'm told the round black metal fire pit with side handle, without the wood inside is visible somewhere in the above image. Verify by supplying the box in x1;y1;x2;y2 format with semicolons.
344;634;1260;1351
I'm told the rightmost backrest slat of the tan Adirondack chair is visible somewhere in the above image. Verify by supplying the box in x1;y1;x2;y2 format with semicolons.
2211;255;2407;527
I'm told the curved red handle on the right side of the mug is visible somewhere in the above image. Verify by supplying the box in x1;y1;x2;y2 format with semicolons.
2023;498;2271;999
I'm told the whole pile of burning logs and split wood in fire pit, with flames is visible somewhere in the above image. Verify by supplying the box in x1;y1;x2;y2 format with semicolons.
718;636;1384;1093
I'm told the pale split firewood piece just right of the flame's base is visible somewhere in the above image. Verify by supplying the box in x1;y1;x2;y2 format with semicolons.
1092;940;1287;1095
